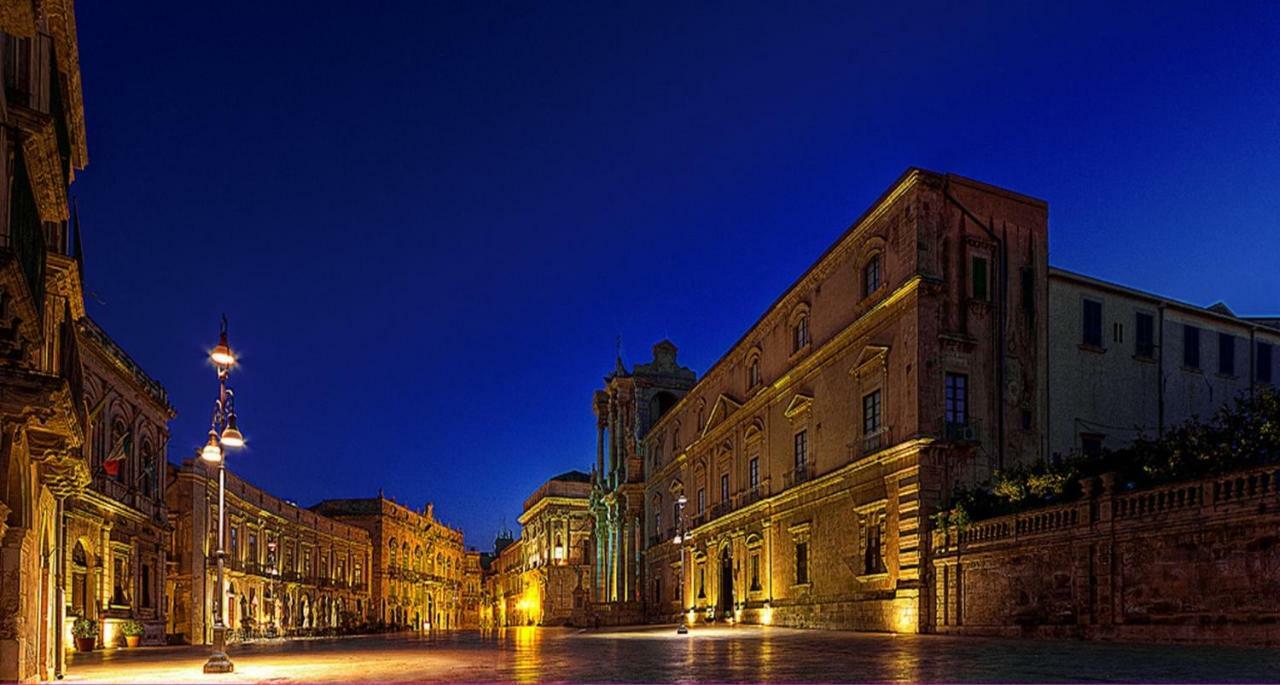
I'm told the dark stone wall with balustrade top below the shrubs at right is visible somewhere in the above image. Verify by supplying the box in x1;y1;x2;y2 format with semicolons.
928;466;1280;645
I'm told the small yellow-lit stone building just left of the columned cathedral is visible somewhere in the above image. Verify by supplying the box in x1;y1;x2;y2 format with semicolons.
520;471;595;625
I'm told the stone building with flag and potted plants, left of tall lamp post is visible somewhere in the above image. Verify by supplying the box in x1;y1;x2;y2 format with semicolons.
63;316;174;647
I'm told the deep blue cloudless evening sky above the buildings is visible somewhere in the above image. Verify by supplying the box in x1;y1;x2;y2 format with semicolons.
74;1;1280;547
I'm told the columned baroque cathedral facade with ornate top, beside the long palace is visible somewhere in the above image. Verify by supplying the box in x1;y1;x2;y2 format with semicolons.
590;341;695;624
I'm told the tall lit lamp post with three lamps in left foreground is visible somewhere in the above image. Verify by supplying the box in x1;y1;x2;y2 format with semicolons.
200;314;244;673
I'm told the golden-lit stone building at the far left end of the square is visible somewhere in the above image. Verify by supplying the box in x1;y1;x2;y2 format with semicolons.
311;494;466;630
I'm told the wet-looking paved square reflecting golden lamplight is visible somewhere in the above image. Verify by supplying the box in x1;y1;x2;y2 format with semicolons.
67;626;1280;684
